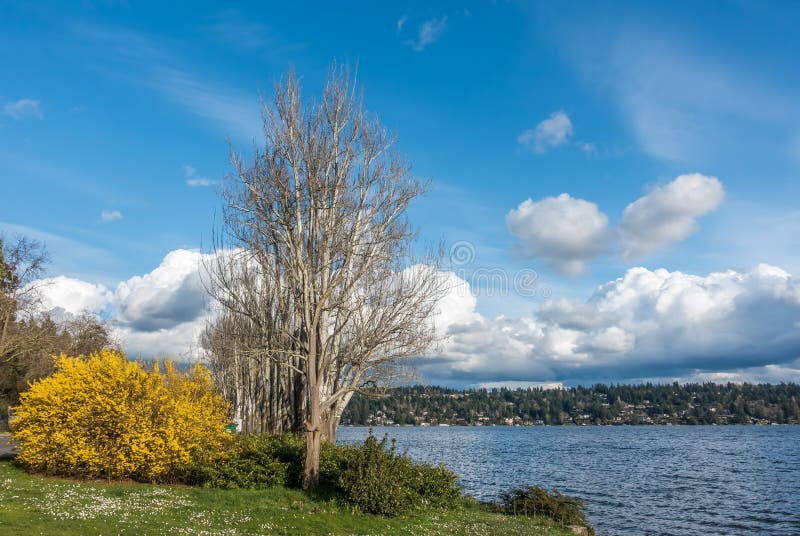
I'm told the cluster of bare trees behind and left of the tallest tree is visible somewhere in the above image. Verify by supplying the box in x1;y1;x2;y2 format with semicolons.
201;244;306;434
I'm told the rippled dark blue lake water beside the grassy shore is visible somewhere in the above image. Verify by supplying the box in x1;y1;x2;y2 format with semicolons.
338;426;800;535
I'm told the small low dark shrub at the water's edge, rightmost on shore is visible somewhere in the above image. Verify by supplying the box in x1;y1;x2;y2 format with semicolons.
499;486;594;534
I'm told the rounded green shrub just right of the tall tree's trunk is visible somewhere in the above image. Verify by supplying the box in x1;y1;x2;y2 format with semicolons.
338;435;460;516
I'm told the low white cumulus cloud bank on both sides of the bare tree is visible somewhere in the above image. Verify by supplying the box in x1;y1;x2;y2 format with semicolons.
34;250;800;386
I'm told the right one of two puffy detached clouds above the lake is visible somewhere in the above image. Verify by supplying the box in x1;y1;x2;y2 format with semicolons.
620;173;725;259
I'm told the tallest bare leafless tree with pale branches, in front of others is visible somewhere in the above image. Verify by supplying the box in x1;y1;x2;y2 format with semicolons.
210;66;443;489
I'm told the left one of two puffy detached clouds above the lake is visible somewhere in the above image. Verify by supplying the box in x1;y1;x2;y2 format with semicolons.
506;194;611;276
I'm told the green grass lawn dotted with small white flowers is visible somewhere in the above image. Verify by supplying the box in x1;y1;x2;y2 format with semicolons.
0;461;572;536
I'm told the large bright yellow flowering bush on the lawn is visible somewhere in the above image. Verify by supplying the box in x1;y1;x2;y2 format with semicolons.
11;350;228;481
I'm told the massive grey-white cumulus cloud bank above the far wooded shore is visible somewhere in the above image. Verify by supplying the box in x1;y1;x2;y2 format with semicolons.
421;265;800;384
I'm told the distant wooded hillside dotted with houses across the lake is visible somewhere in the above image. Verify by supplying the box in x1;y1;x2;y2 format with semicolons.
342;383;800;426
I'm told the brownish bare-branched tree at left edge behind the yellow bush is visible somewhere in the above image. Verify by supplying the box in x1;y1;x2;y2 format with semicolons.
0;237;113;425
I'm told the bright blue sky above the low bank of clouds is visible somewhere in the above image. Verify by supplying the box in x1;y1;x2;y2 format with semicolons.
0;2;800;383
